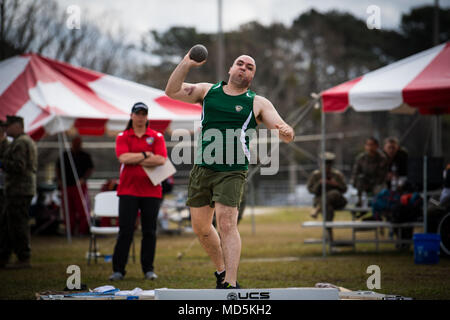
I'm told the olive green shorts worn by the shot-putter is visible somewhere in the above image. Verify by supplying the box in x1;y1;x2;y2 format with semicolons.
186;165;247;208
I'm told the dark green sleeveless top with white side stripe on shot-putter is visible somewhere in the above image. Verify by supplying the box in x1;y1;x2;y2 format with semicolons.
195;81;257;171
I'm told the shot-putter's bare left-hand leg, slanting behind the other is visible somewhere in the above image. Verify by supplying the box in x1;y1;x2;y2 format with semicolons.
190;206;228;273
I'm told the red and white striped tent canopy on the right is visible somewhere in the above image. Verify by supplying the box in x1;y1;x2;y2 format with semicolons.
320;42;450;114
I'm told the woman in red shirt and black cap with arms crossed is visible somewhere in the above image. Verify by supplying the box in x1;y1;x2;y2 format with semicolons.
109;102;167;281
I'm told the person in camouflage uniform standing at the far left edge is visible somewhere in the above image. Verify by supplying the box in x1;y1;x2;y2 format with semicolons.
0;116;37;268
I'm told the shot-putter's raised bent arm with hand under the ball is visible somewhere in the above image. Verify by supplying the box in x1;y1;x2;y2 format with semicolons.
166;52;212;103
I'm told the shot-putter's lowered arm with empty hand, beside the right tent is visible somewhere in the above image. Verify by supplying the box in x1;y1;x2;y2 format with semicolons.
254;96;294;143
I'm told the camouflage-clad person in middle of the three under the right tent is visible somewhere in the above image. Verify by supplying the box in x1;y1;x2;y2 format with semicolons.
351;137;387;206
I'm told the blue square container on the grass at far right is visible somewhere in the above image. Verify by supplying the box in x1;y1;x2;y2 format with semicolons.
413;233;441;264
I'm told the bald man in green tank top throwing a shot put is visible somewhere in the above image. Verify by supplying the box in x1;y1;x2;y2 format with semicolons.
166;48;294;289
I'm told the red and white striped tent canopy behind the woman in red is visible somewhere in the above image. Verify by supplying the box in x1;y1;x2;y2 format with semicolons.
0;54;202;140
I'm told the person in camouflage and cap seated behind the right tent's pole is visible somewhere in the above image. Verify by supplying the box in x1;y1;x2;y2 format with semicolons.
306;152;347;240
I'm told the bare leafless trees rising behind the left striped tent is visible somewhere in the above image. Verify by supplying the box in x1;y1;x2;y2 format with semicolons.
0;0;133;74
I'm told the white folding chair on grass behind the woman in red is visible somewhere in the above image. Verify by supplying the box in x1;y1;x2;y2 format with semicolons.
88;191;135;265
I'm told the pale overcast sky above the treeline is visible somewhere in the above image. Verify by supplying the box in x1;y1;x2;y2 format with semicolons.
58;0;450;39
